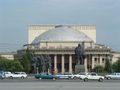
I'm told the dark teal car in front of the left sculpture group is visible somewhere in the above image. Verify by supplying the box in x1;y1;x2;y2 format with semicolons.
35;73;57;80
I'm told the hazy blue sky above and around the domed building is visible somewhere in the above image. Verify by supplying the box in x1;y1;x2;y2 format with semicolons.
0;0;120;52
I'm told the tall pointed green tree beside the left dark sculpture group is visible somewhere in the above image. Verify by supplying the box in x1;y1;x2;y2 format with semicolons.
20;49;31;73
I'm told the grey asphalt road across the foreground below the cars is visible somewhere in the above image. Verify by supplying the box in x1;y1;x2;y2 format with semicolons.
0;79;120;90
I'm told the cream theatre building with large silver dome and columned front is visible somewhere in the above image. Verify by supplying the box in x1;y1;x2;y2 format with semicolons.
18;24;119;73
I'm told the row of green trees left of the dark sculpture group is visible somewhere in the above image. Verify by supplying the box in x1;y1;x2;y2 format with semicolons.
0;49;31;73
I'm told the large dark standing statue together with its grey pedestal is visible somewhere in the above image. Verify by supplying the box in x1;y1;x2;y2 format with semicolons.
75;44;85;73
